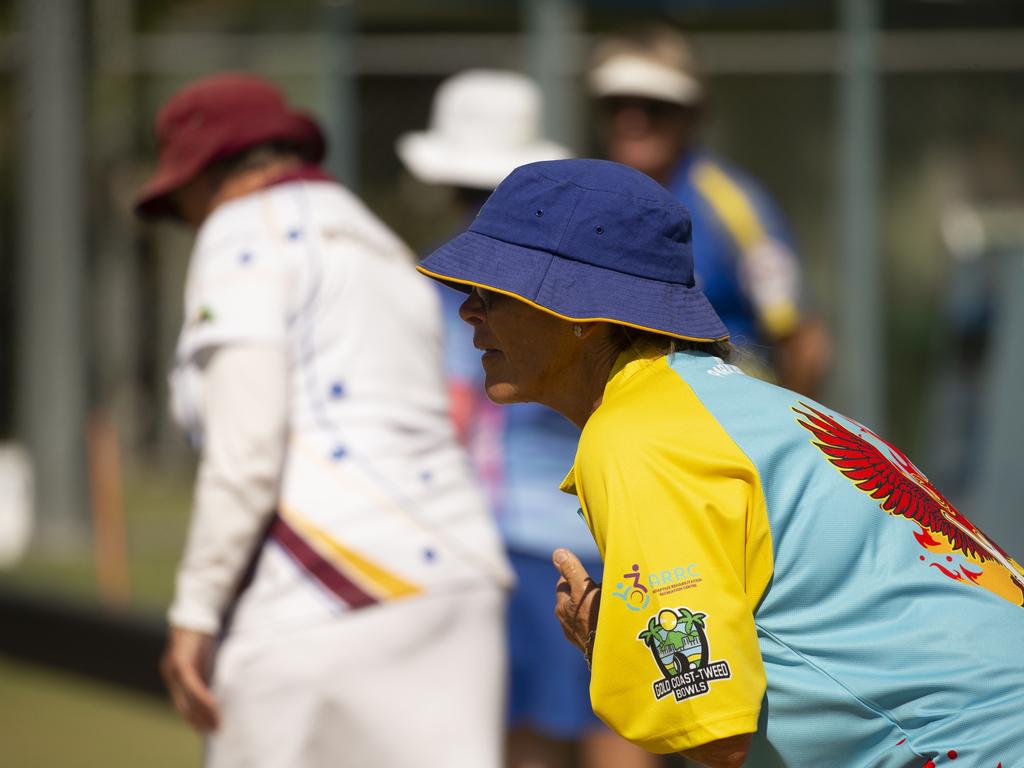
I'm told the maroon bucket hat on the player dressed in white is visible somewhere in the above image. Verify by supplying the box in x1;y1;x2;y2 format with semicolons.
135;74;326;216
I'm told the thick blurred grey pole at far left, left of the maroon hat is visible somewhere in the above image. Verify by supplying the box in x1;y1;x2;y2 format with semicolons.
17;0;89;549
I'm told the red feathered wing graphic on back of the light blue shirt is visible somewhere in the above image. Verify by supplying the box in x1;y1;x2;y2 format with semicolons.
793;402;992;562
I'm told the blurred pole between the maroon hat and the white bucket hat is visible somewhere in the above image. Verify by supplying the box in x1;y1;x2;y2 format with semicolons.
323;0;359;191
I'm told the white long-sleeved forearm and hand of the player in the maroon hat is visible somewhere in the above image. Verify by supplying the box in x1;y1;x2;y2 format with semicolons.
161;344;288;730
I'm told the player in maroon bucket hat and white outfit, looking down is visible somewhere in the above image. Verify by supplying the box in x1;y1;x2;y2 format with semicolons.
136;75;509;768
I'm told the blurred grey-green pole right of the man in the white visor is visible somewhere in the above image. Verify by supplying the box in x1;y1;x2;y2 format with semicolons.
837;0;885;431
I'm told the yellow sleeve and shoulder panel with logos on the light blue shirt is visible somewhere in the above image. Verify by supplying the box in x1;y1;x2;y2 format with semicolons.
566;355;772;753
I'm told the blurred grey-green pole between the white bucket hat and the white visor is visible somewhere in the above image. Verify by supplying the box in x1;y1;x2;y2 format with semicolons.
525;0;583;154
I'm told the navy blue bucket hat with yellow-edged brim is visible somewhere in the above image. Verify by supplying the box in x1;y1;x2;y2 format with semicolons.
417;160;729;341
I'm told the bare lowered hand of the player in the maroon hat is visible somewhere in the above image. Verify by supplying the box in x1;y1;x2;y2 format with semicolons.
160;627;220;731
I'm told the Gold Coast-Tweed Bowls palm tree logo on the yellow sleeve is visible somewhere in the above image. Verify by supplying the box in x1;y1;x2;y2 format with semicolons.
637;607;732;701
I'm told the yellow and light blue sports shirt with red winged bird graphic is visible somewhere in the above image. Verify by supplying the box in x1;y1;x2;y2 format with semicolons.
563;352;1024;768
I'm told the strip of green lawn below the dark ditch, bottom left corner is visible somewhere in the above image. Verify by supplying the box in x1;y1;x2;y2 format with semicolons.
0;656;202;768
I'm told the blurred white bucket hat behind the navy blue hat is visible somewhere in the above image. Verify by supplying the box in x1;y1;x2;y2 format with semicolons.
396;70;571;189
